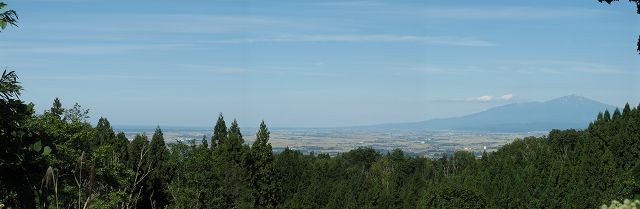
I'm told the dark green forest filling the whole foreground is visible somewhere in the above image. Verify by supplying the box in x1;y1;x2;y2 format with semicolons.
0;71;640;208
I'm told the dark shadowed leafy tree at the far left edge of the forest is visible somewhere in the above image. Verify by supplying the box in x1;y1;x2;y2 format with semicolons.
0;70;42;208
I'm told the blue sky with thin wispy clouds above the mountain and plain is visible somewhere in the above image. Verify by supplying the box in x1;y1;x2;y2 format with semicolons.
0;0;640;127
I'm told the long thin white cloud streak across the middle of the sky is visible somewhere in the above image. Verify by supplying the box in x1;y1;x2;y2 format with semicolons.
203;34;495;47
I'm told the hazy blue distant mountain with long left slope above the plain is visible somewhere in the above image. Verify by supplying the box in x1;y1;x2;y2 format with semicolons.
363;95;616;132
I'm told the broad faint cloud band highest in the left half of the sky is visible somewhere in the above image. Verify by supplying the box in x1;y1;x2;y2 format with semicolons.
31;13;328;34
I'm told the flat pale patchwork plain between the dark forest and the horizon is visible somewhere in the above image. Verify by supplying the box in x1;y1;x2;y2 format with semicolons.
121;127;547;158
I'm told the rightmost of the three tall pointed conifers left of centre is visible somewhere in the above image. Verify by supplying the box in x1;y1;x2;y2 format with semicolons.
251;121;278;208
